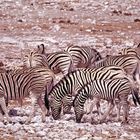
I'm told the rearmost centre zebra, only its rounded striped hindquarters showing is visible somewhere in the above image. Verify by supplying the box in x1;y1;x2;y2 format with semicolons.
66;45;102;68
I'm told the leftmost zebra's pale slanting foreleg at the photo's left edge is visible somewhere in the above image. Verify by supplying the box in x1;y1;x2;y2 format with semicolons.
0;97;12;122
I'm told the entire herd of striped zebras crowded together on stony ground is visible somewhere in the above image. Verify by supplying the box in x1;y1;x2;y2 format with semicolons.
0;44;140;123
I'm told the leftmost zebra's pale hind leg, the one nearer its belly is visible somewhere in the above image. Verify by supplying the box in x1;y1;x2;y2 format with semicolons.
26;92;37;123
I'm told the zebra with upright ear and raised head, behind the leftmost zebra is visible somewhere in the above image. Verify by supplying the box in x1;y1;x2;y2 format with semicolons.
23;44;73;75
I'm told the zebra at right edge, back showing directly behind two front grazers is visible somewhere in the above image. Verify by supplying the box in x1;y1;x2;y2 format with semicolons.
93;54;140;85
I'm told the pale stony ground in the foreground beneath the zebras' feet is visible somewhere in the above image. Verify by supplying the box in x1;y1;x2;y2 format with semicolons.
0;99;140;140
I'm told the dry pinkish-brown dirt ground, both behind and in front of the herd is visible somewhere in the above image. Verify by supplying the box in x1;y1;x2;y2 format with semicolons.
0;0;140;140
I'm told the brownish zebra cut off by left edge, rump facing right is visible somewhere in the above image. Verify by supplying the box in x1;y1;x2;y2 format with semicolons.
0;67;54;122
